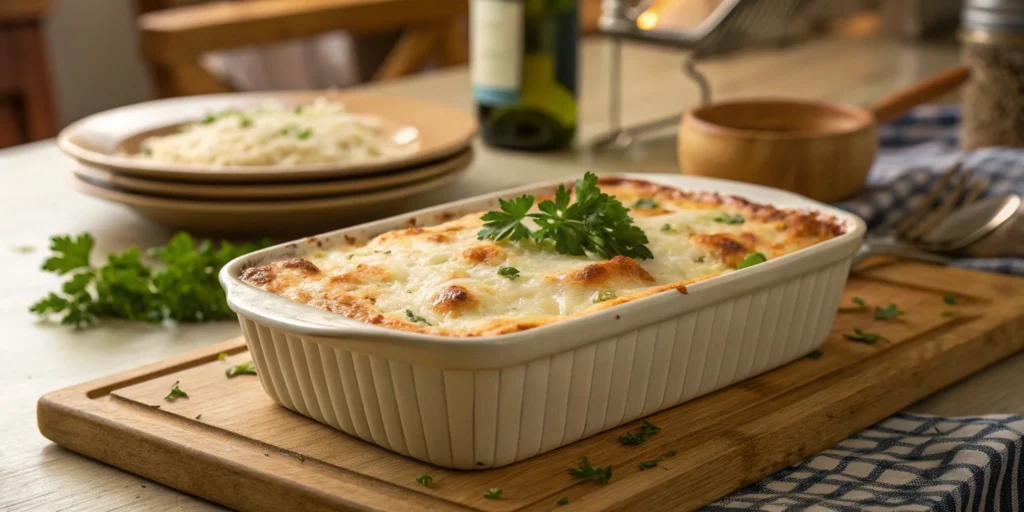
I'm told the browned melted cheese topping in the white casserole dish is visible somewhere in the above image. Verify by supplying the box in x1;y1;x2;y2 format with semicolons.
242;178;843;336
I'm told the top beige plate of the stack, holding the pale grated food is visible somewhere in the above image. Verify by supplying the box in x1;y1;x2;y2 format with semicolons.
57;91;476;183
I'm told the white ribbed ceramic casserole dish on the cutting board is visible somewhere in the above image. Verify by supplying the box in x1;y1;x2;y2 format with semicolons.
220;174;865;469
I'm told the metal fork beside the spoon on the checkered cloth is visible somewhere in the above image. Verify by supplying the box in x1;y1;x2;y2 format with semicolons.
853;162;988;264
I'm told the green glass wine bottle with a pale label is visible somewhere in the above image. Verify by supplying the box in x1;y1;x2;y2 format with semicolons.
470;0;579;151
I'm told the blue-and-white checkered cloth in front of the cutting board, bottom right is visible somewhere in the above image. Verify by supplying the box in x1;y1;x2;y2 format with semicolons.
703;413;1024;512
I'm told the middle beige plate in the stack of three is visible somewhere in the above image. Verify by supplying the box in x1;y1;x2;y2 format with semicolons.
73;150;473;200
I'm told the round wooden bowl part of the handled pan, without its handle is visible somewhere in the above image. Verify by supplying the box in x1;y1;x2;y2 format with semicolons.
679;99;877;203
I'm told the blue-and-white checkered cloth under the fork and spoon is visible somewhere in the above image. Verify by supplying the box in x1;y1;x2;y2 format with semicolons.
837;106;1024;275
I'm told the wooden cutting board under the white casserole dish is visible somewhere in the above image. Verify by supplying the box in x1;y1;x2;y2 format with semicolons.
38;262;1024;511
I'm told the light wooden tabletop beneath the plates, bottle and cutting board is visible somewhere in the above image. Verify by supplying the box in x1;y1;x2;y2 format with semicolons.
0;34;1024;511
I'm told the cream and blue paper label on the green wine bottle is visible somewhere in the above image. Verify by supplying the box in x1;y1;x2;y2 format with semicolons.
469;0;523;105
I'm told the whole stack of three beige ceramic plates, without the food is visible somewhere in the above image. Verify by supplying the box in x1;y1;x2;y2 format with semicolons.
57;91;477;234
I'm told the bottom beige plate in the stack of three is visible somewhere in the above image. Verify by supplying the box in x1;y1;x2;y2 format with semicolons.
69;161;466;236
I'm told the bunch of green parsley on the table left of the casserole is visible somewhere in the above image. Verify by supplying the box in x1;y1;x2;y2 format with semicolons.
30;232;270;329
